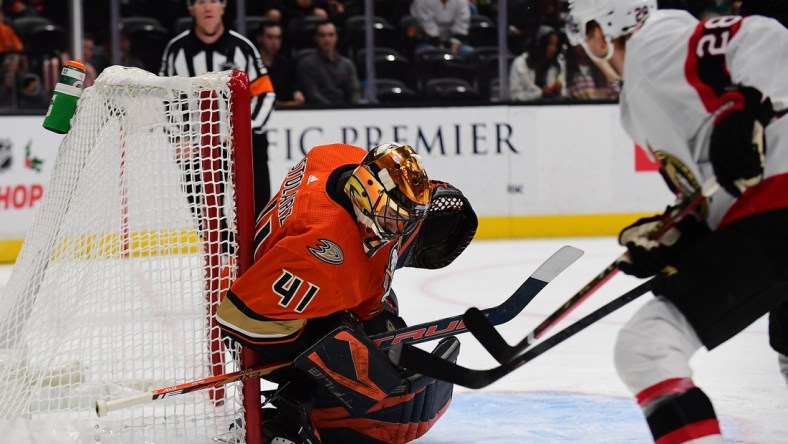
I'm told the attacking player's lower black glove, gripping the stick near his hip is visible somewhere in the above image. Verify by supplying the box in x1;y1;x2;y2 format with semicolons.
616;207;711;278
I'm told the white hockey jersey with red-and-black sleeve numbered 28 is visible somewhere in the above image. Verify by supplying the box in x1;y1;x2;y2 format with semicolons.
620;10;788;228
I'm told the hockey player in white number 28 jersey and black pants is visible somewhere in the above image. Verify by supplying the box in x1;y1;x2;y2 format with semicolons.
567;0;788;443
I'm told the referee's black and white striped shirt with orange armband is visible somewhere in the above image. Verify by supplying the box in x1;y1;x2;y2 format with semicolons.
159;29;276;133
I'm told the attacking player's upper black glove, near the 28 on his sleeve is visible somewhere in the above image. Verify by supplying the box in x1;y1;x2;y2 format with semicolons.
709;85;774;197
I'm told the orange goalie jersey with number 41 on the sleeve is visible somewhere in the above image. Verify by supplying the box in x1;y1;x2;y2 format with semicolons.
217;144;398;357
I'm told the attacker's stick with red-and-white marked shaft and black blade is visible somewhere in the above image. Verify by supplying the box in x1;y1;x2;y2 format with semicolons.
463;178;720;363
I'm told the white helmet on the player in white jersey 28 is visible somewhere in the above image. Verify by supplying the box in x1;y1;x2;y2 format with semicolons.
566;0;657;60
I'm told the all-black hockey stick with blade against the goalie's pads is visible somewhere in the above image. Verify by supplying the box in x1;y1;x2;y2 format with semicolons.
389;280;651;389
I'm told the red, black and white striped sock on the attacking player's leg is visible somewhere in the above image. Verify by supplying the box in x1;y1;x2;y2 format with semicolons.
636;378;722;444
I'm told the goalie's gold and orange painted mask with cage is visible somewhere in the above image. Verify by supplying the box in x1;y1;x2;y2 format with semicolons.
345;143;430;256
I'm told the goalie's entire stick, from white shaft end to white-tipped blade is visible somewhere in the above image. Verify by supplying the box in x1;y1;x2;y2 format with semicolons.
96;245;583;417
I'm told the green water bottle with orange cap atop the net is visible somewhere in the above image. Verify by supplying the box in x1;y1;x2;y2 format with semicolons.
44;59;86;134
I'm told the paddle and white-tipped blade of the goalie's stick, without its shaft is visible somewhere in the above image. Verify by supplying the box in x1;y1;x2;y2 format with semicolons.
370;245;583;350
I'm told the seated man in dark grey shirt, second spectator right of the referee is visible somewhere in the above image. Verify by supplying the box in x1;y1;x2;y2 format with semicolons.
296;22;361;105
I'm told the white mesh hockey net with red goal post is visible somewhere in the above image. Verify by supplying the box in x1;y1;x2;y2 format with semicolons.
0;67;259;444
